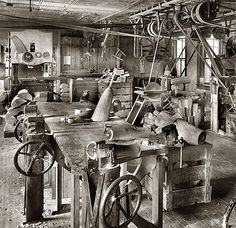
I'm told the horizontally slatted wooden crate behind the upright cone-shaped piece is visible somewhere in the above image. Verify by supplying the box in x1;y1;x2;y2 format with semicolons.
98;79;133;117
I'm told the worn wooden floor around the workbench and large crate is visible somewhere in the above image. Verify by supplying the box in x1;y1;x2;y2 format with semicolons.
0;116;236;228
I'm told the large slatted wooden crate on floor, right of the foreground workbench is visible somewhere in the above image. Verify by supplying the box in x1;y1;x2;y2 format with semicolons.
145;143;212;210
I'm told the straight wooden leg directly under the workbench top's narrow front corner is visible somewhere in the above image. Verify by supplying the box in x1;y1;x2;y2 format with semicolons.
71;173;80;228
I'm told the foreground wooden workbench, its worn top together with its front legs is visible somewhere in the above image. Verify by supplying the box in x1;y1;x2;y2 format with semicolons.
37;102;165;228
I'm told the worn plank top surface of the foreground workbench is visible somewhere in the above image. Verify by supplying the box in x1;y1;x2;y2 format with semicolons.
37;102;124;172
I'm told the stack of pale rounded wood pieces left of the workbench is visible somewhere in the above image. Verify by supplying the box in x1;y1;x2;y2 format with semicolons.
5;89;33;128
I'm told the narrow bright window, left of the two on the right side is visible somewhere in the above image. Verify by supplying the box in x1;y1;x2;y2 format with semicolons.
175;36;186;76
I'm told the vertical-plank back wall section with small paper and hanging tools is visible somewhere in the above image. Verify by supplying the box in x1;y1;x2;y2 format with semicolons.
61;33;118;74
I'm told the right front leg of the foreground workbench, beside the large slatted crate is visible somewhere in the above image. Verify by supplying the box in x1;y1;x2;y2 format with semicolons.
152;155;165;228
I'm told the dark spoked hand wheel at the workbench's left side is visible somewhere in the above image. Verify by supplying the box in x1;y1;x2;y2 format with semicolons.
14;141;55;177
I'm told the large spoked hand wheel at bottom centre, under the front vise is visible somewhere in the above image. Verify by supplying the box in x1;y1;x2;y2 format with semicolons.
101;175;142;228
